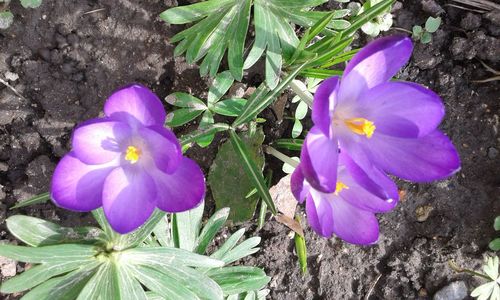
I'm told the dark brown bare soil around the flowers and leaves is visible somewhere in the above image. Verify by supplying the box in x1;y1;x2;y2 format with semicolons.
0;0;500;299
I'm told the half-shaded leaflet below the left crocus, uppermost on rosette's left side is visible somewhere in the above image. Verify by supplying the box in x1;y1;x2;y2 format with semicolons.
6;215;106;247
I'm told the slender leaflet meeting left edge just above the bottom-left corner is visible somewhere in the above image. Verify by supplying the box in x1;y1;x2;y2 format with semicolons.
0;260;92;294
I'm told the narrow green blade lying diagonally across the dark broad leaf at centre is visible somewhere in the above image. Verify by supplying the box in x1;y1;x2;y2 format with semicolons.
229;130;276;214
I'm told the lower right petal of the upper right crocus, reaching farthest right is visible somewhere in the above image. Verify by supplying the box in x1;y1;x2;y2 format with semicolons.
362;130;460;182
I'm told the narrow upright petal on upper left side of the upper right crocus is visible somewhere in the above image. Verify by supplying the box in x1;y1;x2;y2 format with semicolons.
312;76;339;136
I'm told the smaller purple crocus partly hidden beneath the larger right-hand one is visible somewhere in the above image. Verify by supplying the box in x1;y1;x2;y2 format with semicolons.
291;153;398;245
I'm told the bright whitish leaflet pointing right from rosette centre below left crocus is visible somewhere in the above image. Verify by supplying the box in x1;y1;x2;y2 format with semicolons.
120;247;224;268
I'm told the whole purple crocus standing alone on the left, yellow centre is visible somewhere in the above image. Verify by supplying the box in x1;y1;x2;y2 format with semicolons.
51;85;205;234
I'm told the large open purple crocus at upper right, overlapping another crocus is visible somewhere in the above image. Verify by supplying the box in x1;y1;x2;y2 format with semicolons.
301;36;460;193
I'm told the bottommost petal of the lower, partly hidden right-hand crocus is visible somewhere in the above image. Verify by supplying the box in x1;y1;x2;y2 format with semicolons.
330;200;379;245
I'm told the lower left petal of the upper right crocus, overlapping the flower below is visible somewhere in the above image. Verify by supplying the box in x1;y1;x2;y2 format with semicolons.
300;127;338;193
